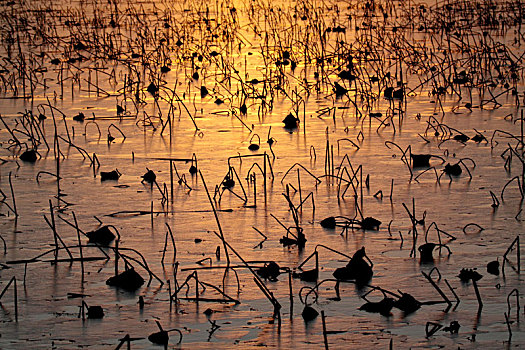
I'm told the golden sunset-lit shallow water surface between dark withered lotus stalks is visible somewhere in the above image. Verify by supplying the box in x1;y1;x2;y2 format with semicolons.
0;1;525;349
